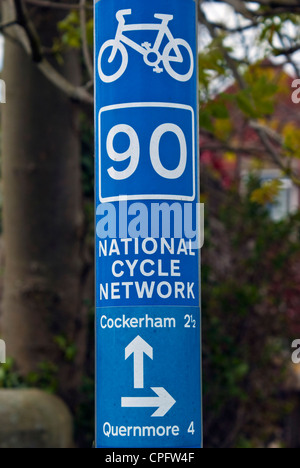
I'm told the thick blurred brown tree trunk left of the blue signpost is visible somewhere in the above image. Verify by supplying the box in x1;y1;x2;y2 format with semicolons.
2;3;86;405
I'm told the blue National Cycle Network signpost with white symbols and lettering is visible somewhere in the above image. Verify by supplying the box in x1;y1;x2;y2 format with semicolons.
95;0;202;448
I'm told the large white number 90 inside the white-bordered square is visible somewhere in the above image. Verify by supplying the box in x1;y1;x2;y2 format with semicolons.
106;123;187;180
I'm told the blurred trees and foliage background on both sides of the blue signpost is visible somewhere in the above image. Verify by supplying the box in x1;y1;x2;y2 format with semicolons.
0;0;300;448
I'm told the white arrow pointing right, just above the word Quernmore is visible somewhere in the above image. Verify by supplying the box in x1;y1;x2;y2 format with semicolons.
122;387;176;418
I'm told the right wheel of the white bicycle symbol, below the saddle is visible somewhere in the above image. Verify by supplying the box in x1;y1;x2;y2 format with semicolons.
163;39;194;82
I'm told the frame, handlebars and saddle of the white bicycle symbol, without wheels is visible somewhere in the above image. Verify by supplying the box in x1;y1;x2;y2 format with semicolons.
109;13;183;63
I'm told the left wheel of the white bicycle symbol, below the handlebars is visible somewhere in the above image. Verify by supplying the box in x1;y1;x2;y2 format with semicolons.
98;39;128;83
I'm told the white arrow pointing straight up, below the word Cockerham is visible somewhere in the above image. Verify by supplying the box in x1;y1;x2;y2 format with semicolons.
125;336;153;388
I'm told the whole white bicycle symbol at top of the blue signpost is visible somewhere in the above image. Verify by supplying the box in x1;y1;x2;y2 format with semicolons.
98;10;194;83
